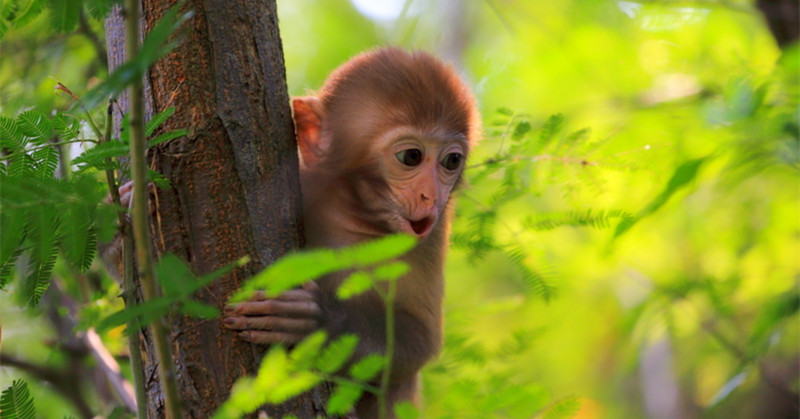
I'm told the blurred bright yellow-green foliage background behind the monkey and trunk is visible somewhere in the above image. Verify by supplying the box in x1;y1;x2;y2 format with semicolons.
0;0;800;418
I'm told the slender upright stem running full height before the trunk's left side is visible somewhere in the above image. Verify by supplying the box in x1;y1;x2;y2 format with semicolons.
125;0;183;419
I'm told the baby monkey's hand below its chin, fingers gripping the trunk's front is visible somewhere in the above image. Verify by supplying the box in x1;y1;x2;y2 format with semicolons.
223;282;322;344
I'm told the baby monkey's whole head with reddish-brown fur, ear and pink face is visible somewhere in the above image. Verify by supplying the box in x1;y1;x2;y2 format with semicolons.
292;48;480;239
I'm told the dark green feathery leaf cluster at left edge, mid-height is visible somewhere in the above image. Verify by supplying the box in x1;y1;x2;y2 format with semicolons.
0;109;184;306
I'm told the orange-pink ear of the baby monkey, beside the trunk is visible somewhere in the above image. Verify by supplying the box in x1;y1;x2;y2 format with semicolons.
292;96;327;167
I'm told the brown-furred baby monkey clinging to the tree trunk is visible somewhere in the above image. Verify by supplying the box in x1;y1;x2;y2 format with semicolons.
224;47;480;418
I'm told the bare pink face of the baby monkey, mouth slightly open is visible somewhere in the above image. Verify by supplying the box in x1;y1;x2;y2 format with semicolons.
378;127;467;240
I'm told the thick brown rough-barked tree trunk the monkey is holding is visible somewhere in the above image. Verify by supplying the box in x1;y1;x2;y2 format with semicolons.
106;0;326;418
